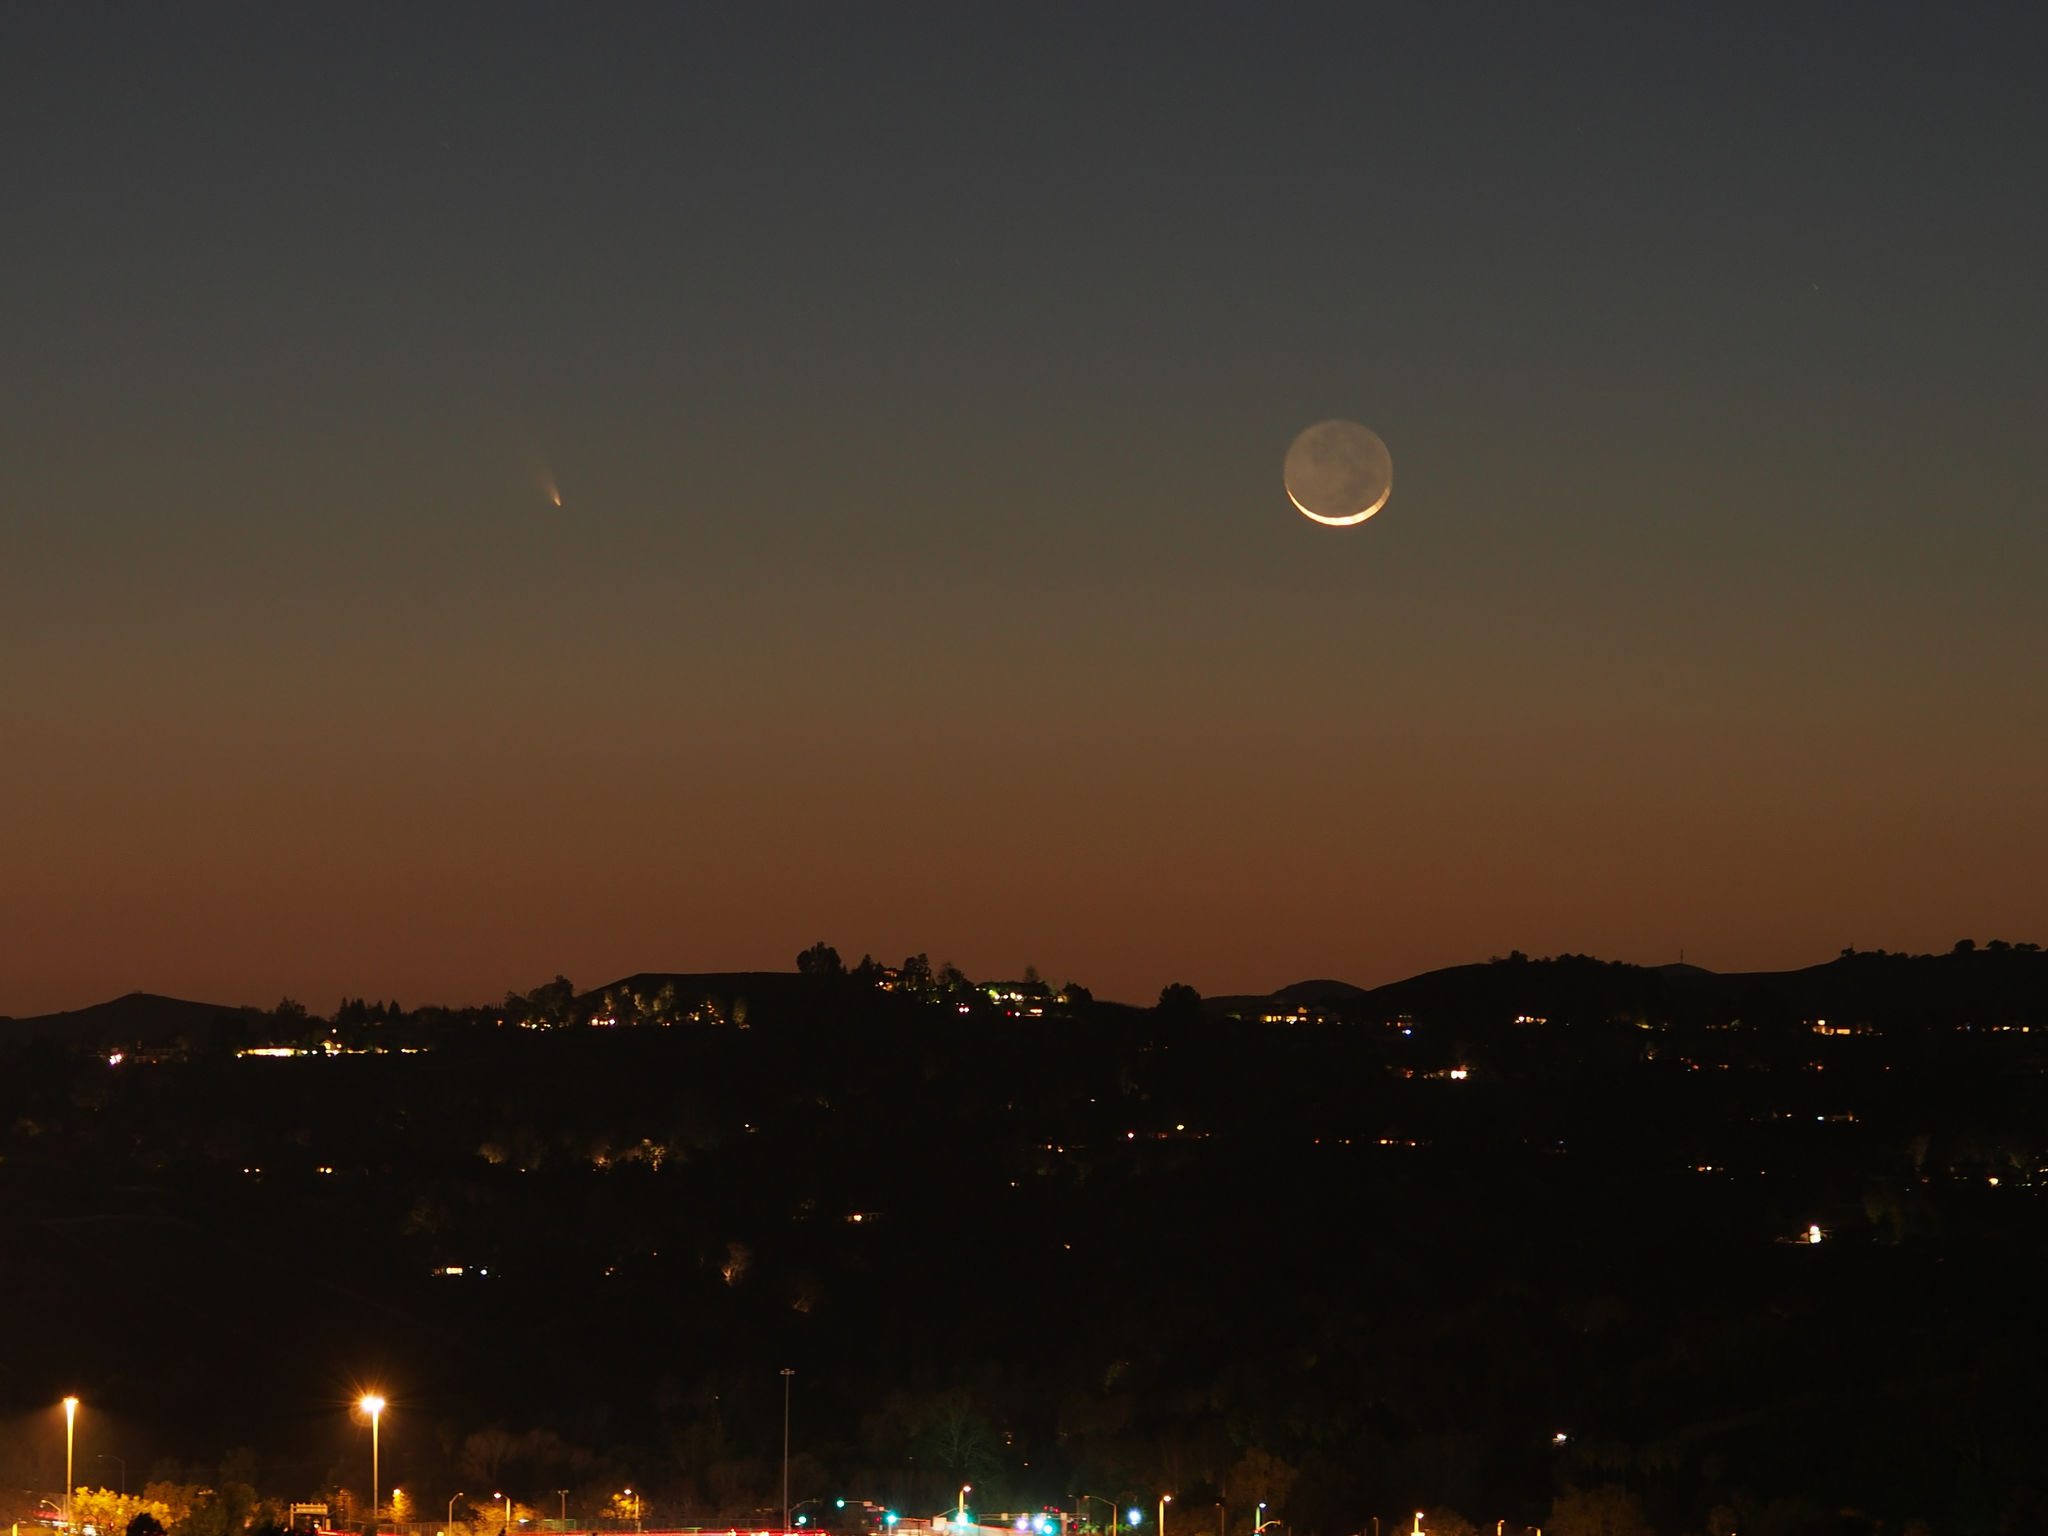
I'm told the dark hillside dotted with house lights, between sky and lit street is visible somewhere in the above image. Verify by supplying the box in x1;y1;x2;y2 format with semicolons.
0;946;2048;1536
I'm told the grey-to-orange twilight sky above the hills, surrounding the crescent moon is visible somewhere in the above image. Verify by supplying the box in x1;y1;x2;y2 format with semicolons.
0;4;2048;1014
